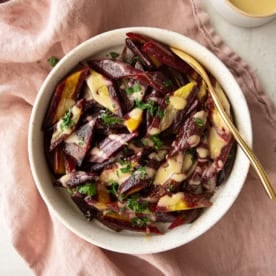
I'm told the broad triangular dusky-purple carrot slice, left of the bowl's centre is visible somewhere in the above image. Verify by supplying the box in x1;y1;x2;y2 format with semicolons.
64;119;96;166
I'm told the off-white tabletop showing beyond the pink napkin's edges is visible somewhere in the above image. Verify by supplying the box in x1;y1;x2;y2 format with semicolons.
0;0;276;276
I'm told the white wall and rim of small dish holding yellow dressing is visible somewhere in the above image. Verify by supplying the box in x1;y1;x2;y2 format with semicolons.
210;0;276;28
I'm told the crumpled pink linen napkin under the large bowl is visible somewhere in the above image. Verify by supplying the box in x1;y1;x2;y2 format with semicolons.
0;0;276;276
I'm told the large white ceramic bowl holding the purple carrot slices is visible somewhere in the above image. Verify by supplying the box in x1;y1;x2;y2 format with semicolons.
28;27;252;254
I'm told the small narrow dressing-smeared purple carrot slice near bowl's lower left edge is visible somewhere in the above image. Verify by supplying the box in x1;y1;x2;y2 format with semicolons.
55;171;98;188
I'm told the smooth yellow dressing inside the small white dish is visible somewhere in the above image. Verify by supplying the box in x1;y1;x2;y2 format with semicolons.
229;0;276;16
